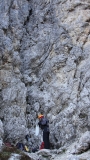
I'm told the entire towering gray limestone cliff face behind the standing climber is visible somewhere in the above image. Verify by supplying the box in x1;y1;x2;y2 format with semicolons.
0;0;90;151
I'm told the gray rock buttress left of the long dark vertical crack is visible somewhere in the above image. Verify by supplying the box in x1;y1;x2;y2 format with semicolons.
0;0;28;140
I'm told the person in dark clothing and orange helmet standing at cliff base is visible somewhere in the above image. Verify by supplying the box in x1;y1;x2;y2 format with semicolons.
38;114;50;149
